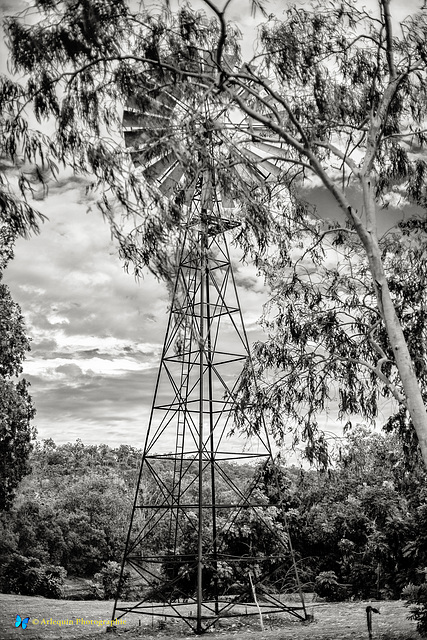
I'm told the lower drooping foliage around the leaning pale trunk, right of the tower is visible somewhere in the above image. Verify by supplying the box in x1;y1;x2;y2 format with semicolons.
240;218;427;466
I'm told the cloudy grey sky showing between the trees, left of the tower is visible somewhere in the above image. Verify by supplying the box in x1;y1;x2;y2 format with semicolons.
0;0;421;456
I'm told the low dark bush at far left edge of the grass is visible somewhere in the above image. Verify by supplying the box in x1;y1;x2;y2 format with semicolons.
0;554;66;599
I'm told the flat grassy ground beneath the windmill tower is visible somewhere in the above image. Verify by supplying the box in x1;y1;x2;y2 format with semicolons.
0;594;420;640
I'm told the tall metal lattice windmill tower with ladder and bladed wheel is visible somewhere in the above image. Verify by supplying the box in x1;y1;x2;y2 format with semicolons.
113;60;306;633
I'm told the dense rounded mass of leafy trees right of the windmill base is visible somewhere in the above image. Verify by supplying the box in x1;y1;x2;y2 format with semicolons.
287;427;425;598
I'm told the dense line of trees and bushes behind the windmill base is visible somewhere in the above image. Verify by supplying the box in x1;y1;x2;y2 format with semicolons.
0;427;427;600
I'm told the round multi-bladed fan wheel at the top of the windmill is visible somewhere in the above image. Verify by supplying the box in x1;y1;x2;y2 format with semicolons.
123;50;288;210
